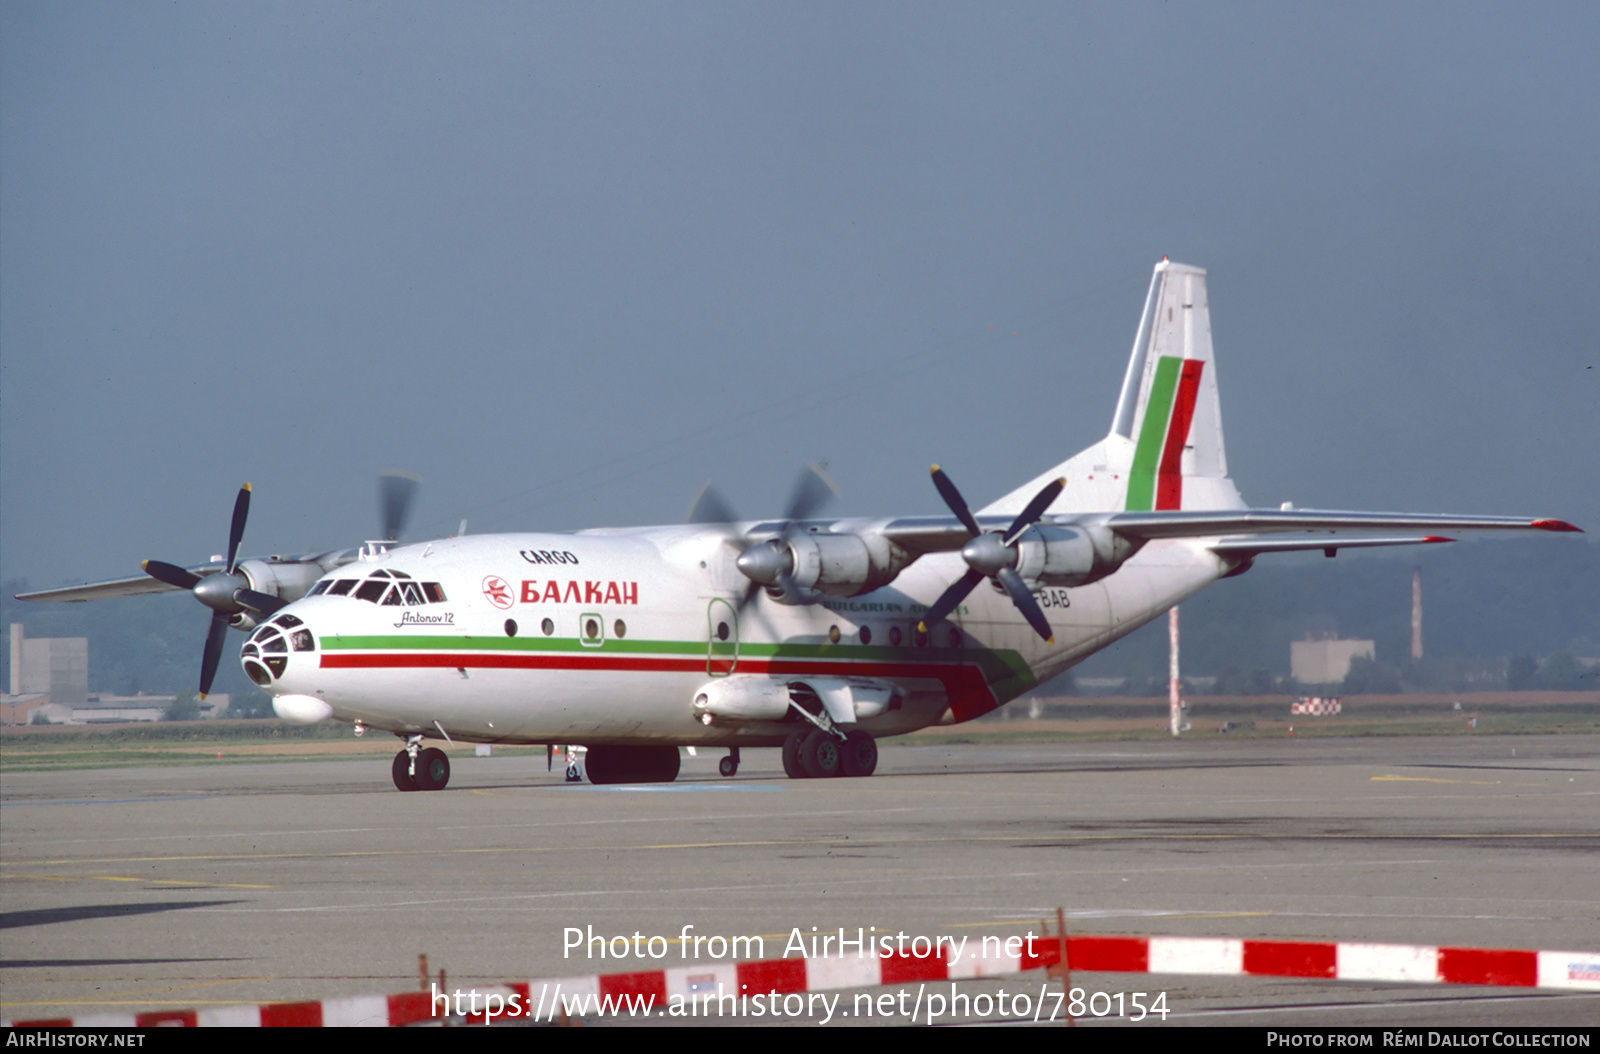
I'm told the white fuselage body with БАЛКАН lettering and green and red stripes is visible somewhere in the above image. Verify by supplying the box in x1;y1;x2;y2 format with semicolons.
256;526;1230;745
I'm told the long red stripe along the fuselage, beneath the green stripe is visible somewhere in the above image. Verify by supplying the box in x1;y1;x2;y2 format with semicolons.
322;653;1000;721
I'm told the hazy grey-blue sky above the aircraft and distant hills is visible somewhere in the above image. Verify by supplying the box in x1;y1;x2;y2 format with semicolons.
0;0;1600;589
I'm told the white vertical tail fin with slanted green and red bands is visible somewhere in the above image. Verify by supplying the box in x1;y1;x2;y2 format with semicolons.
984;259;1245;513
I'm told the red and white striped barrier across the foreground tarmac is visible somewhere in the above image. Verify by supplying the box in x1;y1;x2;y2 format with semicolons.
12;934;1600;1028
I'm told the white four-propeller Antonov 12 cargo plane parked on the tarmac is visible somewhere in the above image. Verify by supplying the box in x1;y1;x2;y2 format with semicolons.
26;259;1578;790
